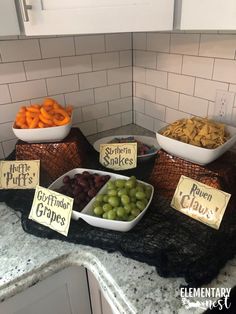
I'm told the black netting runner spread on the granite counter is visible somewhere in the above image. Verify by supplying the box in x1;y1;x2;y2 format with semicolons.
0;129;236;287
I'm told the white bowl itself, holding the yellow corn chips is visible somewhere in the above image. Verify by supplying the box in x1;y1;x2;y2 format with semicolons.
156;126;236;165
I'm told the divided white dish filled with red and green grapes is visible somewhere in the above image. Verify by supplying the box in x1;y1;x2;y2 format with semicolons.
49;168;154;232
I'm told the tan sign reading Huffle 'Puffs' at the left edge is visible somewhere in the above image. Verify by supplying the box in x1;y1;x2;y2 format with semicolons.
0;160;40;189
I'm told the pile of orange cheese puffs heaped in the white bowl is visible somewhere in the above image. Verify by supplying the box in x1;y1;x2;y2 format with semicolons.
15;98;72;129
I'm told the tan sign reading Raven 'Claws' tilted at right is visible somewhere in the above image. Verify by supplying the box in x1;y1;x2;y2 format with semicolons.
171;176;231;229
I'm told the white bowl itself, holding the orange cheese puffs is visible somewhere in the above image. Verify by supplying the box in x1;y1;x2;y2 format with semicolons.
12;119;72;143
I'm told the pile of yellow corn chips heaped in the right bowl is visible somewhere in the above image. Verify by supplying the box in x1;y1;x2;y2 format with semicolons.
160;117;229;149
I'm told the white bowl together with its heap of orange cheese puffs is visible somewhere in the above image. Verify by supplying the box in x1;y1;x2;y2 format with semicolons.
12;98;72;143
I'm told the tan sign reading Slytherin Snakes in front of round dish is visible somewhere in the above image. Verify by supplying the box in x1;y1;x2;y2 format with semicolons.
100;143;137;170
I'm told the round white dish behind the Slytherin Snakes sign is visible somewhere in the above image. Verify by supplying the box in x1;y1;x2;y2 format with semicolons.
93;135;160;161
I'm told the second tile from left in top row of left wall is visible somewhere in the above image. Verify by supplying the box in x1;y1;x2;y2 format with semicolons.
39;36;75;58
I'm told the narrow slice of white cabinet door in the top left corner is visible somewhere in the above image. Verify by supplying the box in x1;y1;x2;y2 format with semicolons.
0;0;20;36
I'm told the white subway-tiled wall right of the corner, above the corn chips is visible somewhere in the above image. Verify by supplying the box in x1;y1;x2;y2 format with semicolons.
133;32;236;131
